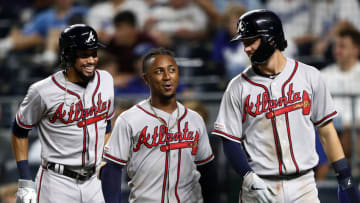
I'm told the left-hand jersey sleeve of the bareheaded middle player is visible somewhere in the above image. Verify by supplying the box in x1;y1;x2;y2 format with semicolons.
104;116;131;165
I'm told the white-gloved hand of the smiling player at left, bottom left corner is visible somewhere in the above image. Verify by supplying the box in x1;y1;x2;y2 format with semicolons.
16;179;36;203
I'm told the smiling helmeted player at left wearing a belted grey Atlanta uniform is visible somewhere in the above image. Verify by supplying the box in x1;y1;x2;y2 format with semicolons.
12;24;114;203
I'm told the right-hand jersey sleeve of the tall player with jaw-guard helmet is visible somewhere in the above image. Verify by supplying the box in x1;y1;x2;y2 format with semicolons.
311;70;337;127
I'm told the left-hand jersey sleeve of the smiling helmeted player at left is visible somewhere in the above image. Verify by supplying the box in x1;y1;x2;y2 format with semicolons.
15;85;46;129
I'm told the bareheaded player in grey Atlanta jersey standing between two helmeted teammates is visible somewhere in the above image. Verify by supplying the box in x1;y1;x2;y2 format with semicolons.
100;48;218;203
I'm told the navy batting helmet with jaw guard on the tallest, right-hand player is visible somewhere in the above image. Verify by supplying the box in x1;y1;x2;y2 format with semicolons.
231;9;287;64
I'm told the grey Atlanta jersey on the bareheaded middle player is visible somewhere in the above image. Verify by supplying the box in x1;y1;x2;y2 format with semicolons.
104;100;214;203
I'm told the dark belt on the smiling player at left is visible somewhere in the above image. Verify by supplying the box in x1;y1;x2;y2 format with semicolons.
43;162;95;181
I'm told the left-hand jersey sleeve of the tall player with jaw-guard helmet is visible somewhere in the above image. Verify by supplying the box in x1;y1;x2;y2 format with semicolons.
212;88;242;142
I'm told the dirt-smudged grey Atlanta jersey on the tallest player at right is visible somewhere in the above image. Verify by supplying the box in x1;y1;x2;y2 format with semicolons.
212;58;337;175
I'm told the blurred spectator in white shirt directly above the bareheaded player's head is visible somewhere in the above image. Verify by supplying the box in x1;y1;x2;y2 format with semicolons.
145;0;208;57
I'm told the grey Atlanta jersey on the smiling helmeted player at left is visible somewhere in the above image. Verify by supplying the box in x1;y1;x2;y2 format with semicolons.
16;70;114;167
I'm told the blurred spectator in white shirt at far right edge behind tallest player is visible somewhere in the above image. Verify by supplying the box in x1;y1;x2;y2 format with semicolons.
321;23;360;157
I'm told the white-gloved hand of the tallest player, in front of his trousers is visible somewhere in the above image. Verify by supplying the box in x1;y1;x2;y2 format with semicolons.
239;172;276;203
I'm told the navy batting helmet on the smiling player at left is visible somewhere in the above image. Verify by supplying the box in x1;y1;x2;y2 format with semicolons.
59;24;104;65
